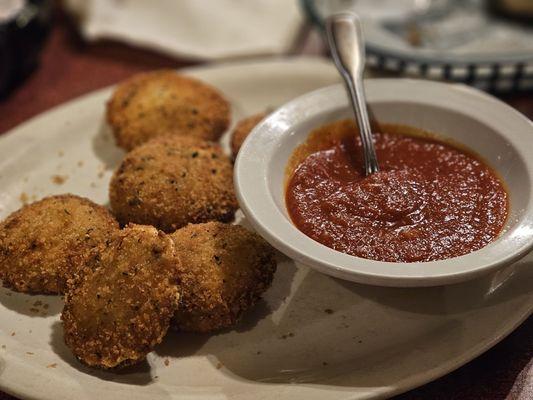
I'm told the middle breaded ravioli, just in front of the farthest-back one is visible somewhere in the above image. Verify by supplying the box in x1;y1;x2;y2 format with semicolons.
110;136;238;232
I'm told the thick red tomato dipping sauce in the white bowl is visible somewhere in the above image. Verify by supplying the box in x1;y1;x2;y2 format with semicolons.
286;121;508;262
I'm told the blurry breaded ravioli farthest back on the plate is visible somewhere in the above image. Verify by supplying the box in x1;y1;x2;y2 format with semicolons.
107;70;231;150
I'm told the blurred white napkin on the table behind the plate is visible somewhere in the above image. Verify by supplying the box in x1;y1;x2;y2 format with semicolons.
64;0;304;60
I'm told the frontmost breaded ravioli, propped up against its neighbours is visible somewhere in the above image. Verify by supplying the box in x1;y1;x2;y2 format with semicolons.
61;225;179;369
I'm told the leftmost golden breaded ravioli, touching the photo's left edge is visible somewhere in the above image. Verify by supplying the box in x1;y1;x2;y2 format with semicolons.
0;194;119;293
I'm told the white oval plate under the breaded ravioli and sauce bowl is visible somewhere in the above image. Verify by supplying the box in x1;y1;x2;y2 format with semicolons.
0;59;533;400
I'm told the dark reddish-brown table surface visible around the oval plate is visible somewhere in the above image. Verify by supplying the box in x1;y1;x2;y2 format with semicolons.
0;7;533;400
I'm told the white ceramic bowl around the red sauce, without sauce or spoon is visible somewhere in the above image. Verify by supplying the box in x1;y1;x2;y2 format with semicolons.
235;79;533;286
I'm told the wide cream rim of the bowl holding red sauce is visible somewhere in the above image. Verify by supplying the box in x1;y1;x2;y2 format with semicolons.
234;78;533;287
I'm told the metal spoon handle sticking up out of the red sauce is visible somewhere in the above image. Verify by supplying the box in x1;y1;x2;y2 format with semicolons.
326;13;379;175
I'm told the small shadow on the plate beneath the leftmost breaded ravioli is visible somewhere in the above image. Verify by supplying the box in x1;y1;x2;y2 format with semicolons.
0;288;63;317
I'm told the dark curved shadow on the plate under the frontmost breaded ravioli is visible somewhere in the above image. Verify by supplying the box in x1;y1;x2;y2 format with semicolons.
50;321;154;386
